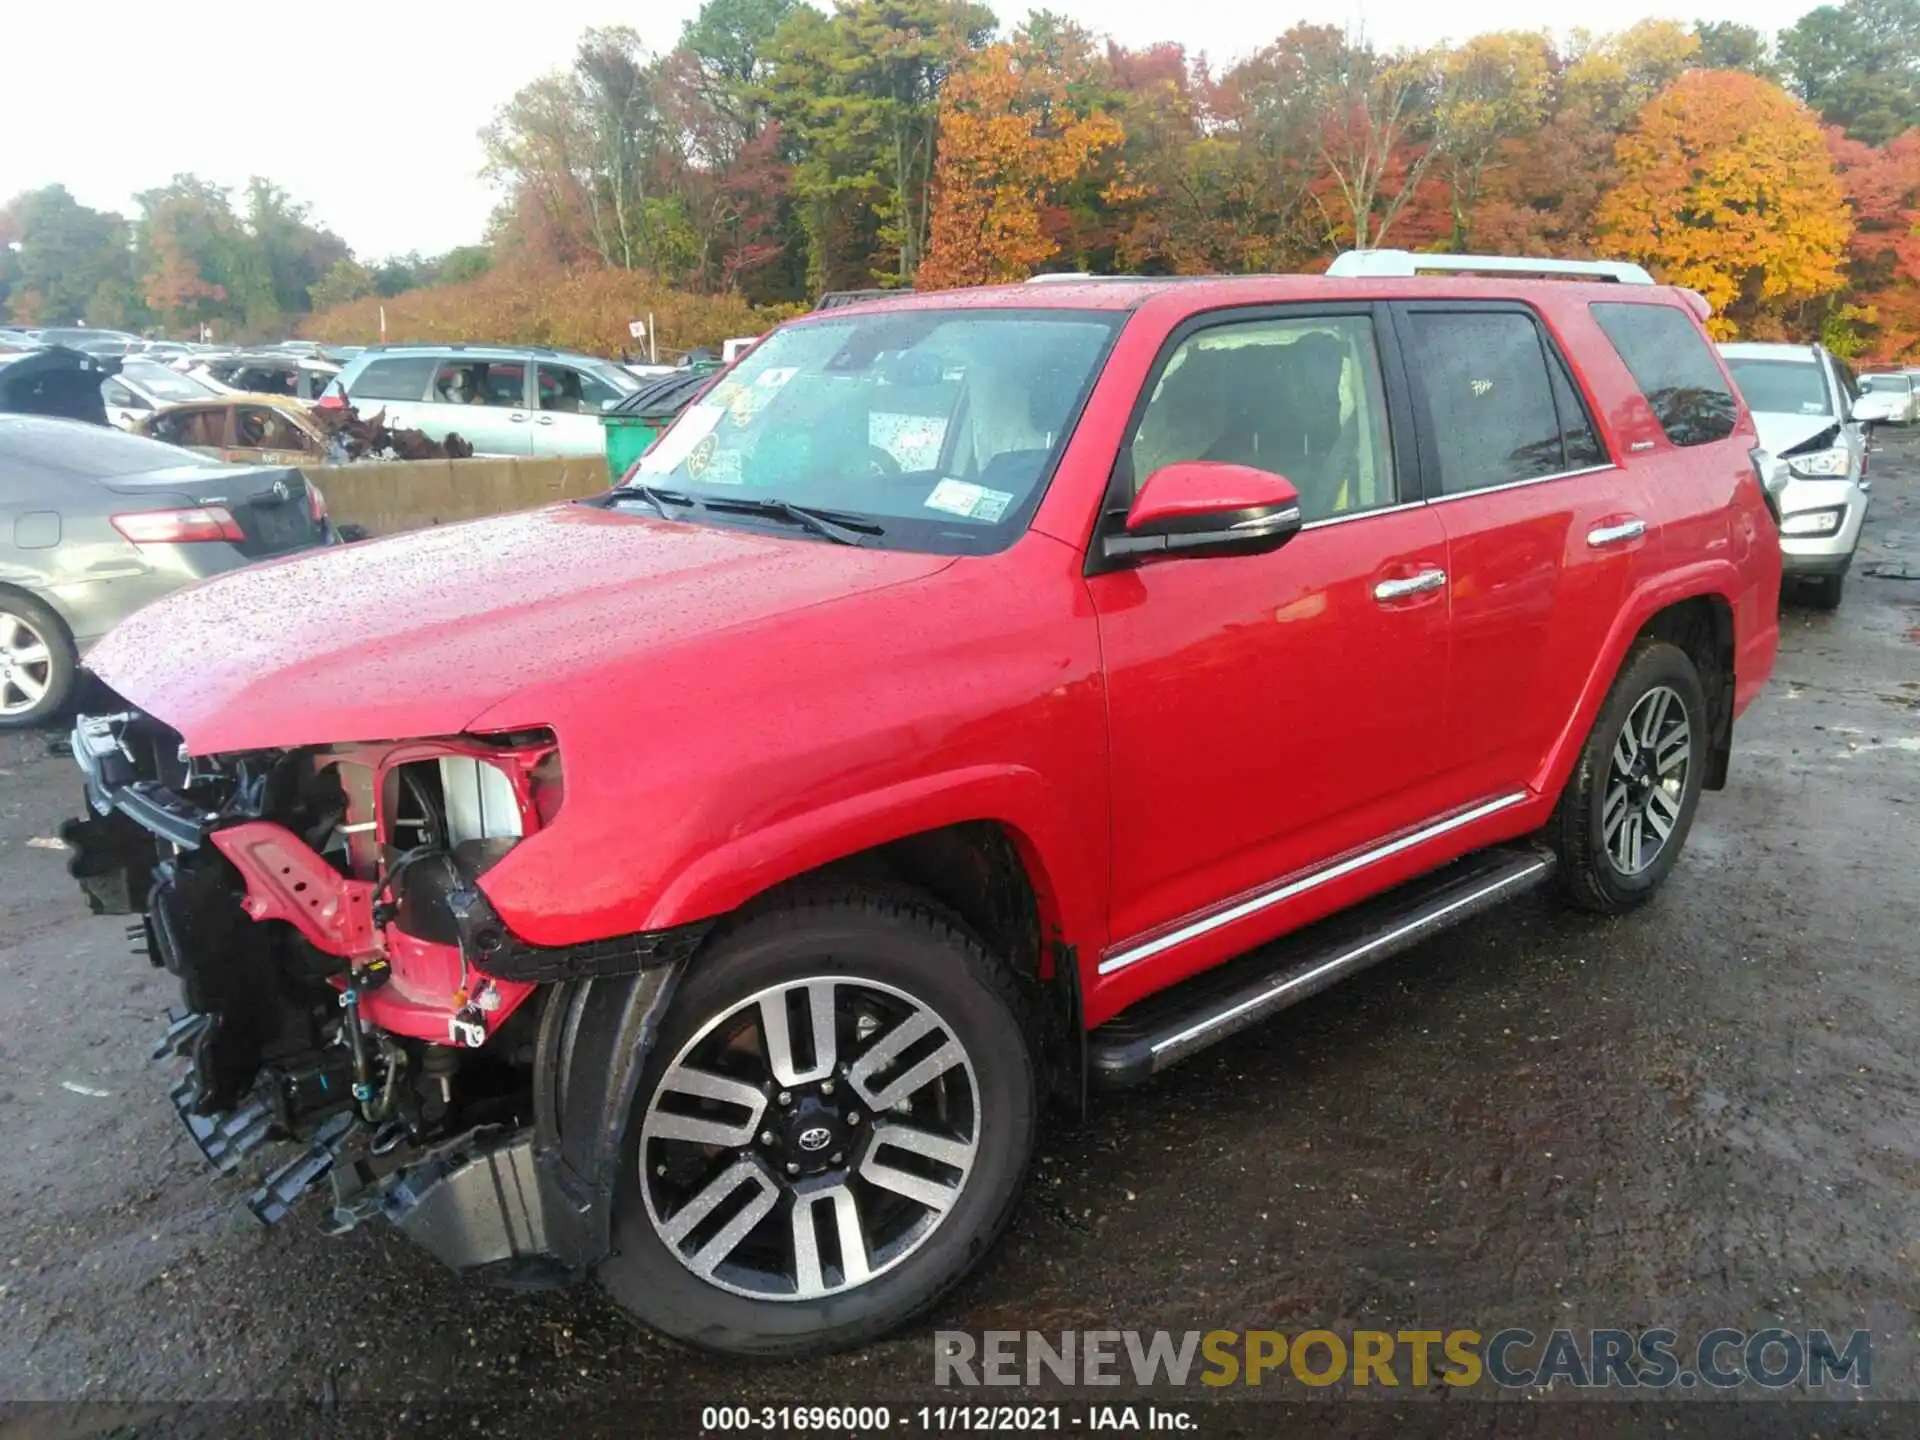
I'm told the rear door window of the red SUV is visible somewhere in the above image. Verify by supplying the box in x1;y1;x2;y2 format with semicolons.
1407;311;1605;495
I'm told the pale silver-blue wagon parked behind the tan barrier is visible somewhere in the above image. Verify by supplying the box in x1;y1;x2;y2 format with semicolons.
326;346;639;455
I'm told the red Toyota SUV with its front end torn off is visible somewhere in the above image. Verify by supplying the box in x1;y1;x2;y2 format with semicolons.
67;252;1780;1354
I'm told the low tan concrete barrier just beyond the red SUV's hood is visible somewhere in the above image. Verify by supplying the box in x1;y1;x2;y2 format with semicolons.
301;457;609;536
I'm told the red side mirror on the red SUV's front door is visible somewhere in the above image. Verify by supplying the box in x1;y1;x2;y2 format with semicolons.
1100;461;1300;561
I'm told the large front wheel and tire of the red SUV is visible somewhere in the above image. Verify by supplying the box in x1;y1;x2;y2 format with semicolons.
599;891;1039;1356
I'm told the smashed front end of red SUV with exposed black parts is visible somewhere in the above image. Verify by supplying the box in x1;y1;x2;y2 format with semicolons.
63;708;705;1283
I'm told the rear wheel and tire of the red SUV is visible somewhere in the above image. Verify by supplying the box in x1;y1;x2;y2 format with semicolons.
1548;639;1713;916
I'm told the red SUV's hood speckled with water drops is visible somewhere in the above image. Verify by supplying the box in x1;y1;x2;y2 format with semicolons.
86;505;952;755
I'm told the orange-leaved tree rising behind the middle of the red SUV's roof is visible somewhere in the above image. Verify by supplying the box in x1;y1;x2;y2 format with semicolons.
914;42;1125;290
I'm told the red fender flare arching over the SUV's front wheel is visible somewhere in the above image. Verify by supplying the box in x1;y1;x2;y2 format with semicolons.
647;764;1104;954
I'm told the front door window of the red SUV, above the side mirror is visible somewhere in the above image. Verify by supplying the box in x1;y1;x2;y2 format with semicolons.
1129;315;1396;522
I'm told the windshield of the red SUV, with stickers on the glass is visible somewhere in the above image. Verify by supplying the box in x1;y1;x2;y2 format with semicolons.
632;309;1125;553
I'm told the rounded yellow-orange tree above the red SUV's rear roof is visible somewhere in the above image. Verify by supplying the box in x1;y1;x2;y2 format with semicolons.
1597;71;1853;336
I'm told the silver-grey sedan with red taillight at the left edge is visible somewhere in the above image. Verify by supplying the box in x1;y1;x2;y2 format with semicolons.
0;415;332;730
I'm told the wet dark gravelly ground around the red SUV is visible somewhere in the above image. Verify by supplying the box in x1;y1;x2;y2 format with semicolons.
0;434;1920;1434
